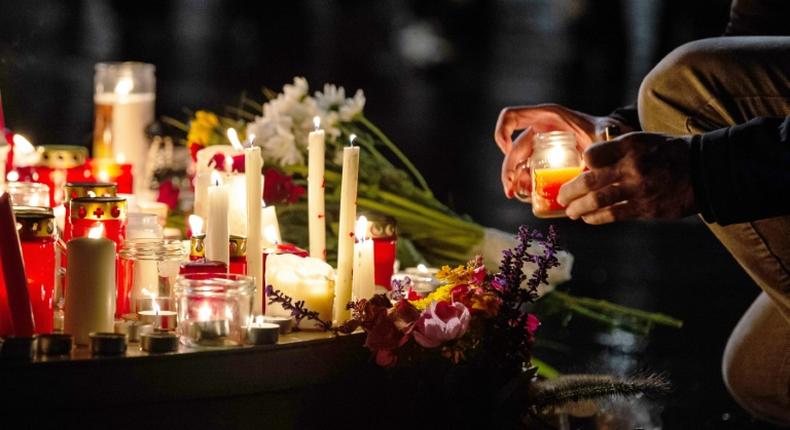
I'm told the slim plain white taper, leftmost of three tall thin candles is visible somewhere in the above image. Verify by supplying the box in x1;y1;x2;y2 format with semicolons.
244;146;263;315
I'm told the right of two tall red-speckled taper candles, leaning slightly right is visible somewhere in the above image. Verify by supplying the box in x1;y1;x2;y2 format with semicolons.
332;139;359;324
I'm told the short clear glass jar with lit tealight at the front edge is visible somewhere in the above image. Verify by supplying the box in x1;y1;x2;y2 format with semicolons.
175;273;255;348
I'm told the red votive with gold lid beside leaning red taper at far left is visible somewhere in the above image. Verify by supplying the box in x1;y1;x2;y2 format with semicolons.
14;207;57;333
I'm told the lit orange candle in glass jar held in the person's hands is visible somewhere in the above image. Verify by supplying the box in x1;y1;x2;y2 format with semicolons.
529;131;583;218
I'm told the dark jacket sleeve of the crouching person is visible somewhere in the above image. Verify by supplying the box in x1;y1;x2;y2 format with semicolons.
689;117;790;225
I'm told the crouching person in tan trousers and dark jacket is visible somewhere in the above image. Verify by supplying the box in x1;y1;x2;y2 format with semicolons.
495;0;790;425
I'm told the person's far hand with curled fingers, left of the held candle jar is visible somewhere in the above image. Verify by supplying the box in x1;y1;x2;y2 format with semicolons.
494;104;630;198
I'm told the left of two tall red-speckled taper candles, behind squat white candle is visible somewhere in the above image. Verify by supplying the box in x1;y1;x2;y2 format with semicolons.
307;117;326;260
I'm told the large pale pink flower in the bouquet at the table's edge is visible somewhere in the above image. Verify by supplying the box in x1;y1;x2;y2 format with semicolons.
413;301;471;348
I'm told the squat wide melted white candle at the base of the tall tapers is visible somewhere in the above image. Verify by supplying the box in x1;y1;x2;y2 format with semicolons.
266;254;335;328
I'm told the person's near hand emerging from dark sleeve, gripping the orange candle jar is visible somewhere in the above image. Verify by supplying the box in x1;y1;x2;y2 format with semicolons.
557;133;695;224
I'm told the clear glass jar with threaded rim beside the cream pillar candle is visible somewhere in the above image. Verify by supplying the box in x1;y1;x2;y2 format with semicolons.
118;238;187;316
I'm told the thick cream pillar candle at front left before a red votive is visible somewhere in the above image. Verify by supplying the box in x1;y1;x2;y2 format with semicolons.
63;227;115;345
